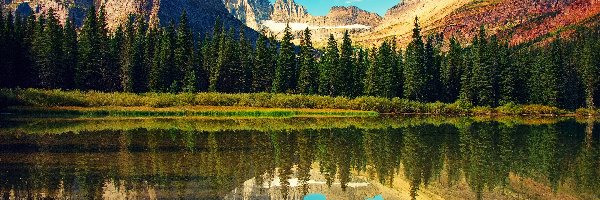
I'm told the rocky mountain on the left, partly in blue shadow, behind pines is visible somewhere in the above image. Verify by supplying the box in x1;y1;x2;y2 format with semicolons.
6;0;257;36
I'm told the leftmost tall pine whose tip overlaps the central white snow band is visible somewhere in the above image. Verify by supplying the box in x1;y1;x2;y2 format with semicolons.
273;24;298;93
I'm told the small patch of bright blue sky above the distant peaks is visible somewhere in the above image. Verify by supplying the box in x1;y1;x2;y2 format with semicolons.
270;0;400;16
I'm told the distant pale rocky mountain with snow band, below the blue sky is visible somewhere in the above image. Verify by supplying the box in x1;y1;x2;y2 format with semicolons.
223;0;382;46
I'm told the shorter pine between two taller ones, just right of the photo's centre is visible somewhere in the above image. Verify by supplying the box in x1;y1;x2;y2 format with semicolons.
319;34;340;96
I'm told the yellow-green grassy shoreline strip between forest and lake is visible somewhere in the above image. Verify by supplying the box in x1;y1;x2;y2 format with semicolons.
0;89;600;117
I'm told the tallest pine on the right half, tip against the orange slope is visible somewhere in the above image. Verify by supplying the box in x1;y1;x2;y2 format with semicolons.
404;18;428;102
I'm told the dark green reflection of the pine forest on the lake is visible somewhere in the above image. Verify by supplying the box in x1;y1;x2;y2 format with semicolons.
0;121;600;198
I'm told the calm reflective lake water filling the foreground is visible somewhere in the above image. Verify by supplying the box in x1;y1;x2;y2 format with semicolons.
0;117;600;199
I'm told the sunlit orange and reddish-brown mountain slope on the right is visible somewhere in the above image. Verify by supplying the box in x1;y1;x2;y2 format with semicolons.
356;0;600;45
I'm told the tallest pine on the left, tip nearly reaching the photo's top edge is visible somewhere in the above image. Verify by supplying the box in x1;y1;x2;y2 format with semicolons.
75;5;103;90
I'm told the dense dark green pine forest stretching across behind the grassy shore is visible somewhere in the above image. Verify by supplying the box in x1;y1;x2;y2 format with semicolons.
0;8;600;109
